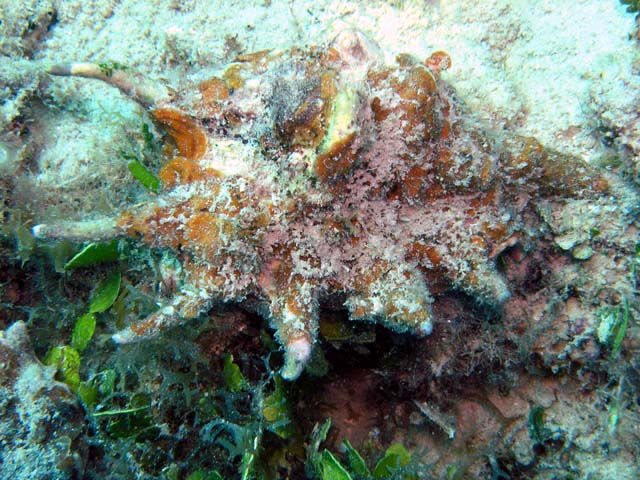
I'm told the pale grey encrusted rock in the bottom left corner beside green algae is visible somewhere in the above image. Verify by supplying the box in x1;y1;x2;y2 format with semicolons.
0;322;86;480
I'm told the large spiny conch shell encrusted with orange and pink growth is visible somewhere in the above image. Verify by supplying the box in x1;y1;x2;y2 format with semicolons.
34;30;607;379
